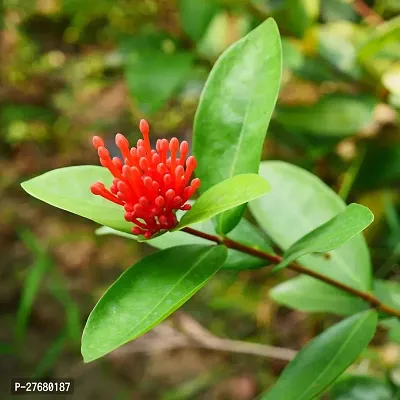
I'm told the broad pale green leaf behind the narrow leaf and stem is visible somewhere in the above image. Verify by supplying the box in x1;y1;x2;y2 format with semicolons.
249;161;371;290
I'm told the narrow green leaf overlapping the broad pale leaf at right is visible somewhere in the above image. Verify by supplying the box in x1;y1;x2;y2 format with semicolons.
273;204;374;271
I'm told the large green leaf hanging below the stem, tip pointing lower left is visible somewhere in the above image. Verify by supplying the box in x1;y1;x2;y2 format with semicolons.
82;245;227;362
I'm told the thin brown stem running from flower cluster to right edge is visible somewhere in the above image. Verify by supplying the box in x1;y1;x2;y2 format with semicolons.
182;228;400;318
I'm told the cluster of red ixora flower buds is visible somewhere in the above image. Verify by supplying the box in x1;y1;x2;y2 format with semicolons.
90;119;200;239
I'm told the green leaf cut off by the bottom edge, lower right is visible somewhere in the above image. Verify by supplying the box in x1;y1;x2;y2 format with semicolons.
262;310;378;400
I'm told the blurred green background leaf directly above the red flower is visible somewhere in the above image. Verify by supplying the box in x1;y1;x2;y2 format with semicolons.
122;34;193;114
